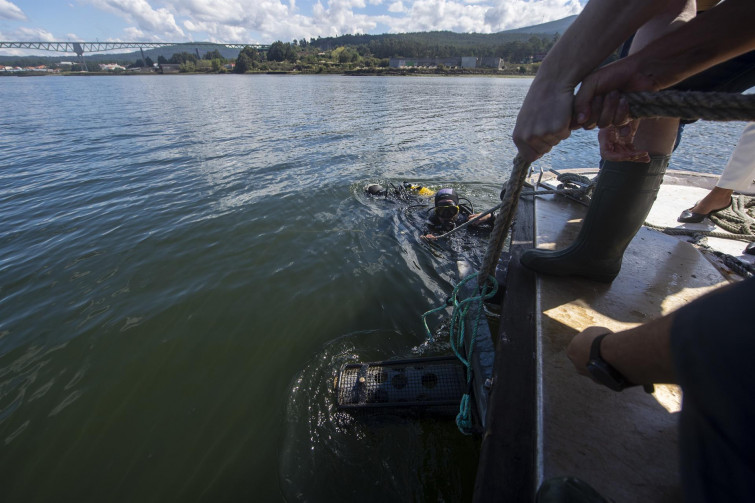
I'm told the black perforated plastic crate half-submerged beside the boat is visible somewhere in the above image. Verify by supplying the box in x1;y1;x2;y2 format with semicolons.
335;356;467;415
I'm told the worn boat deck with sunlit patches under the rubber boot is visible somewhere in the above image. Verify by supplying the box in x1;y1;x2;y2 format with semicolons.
476;172;750;502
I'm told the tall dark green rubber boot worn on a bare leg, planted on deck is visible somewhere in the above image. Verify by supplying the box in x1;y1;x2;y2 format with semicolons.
520;155;670;283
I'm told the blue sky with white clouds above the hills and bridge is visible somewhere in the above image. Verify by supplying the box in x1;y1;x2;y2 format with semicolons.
0;0;587;55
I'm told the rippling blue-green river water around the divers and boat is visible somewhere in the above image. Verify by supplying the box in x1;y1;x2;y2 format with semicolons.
0;75;742;502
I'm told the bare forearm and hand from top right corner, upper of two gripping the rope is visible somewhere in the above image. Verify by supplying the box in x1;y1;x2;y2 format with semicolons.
574;0;755;128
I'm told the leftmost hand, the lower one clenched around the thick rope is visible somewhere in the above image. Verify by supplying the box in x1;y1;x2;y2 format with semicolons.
513;79;574;162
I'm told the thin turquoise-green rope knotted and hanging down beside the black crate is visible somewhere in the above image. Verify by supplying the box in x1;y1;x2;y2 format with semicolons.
422;273;498;435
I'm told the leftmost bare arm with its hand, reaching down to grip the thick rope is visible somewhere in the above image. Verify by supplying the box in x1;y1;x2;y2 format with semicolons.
513;0;685;162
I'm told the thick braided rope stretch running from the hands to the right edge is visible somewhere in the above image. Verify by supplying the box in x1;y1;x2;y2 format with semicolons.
624;91;755;122
